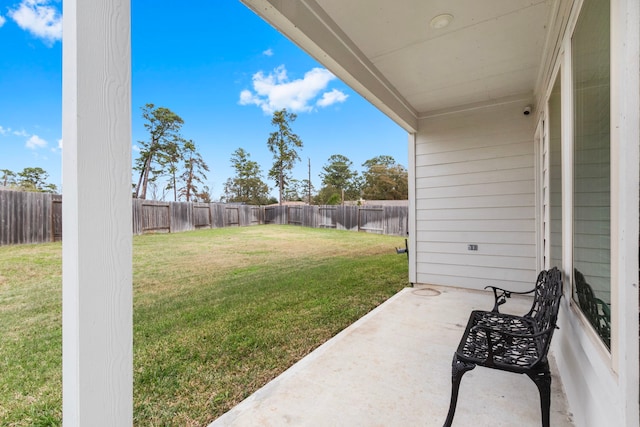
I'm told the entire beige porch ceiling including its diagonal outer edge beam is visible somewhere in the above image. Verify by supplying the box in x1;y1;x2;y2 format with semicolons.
242;0;556;131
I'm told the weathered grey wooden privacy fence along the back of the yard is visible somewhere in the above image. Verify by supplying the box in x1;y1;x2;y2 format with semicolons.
0;191;409;245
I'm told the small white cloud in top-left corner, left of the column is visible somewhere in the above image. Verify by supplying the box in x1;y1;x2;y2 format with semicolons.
9;0;62;44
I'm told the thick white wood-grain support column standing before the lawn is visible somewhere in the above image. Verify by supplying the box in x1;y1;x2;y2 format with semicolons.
62;0;133;427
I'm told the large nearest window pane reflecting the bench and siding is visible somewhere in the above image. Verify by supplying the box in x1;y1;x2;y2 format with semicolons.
571;0;611;348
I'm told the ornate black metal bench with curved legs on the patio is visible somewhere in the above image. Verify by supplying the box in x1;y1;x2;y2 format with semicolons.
444;267;562;427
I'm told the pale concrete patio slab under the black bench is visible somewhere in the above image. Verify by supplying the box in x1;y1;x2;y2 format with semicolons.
210;286;573;427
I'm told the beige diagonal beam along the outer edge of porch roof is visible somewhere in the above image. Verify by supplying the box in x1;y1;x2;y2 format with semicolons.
241;0;418;132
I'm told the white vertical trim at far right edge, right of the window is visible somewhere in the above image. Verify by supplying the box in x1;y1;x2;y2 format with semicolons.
611;0;640;425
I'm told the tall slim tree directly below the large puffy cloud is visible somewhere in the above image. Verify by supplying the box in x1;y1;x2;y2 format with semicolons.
267;108;302;204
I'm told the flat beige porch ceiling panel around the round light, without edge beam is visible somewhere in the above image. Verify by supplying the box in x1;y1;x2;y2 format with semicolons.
318;0;549;113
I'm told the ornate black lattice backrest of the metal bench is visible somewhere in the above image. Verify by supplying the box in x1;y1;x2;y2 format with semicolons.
525;267;562;354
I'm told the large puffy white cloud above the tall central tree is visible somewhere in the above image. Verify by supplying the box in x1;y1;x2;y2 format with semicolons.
239;65;346;113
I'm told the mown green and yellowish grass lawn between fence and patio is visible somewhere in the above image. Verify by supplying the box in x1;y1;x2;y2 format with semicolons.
0;225;407;426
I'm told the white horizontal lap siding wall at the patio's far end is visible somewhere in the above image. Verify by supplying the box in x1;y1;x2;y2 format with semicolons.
415;103;536;290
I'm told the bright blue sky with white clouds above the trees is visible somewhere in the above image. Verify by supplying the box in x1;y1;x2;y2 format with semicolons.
0;0;407;199
